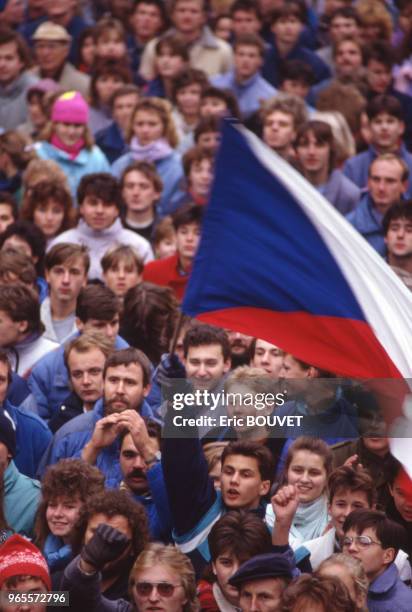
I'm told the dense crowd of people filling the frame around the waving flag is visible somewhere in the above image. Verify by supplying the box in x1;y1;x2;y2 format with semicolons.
0;0;412;612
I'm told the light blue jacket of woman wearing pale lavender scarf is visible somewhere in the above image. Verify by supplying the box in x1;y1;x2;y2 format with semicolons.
112;151;184;217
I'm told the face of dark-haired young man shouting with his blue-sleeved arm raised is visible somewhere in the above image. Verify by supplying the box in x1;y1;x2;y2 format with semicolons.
220;455;270;510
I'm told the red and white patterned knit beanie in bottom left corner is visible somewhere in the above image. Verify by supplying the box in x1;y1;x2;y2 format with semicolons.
0;534;51;591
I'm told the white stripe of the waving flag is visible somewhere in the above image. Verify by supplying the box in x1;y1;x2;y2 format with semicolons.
237;126;412;378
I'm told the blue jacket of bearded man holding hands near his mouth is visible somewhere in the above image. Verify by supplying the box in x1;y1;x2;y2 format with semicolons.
39;399;158;488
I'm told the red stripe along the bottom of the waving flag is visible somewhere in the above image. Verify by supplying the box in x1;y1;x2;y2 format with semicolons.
196;307;402;378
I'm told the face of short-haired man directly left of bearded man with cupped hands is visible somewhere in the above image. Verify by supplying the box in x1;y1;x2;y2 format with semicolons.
67;347;106;404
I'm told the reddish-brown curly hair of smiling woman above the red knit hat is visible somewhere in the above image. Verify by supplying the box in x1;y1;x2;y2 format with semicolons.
34;459;104;549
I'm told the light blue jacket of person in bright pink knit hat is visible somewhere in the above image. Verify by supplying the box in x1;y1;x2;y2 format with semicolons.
34;140;110;200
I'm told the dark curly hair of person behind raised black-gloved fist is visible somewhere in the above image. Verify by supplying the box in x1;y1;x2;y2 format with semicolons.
71;489;149;559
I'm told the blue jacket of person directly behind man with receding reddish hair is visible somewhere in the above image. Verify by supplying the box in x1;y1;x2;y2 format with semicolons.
28;333;129;421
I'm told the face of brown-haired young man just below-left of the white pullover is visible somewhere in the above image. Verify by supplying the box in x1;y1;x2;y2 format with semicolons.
46;257;87;302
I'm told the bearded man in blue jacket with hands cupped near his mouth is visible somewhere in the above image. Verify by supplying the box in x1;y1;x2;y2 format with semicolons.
41;348;158;487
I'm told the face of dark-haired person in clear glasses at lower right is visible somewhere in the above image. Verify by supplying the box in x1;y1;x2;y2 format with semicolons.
343;527;395;582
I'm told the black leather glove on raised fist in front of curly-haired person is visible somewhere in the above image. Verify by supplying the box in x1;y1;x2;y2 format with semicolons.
80;523;130;570
